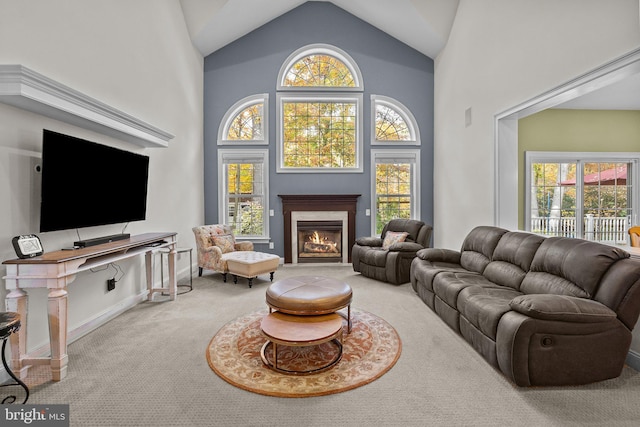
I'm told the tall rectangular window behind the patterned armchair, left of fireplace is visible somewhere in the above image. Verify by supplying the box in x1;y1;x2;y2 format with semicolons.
218;149;269;241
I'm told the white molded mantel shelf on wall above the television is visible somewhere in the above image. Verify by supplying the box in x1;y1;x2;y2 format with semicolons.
0;64;173;147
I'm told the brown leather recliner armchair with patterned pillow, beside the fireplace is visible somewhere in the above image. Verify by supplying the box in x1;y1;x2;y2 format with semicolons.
351;219;431;285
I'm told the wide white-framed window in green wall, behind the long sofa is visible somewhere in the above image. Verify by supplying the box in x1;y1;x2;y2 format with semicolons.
526;152;639;244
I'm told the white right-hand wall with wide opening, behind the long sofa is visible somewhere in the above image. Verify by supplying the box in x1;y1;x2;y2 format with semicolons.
434;0;640;351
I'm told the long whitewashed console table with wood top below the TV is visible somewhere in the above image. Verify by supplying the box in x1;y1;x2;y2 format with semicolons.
3;232;177;381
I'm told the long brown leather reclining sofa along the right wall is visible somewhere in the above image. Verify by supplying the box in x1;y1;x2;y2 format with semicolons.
410;226;640;386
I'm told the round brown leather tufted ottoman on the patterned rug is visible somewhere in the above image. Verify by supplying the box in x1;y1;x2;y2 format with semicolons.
266;276;353;332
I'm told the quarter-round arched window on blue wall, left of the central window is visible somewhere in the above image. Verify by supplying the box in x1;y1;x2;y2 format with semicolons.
218;93;269;145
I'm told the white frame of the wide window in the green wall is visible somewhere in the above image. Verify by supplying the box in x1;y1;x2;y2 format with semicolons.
523;151;640;244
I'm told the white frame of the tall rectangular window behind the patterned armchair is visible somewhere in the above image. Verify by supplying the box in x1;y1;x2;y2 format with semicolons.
218;148;271;243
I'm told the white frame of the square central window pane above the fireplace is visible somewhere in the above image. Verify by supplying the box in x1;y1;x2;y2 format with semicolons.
276;92;364;173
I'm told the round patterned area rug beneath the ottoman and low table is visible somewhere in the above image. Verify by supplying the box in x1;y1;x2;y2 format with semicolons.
207;309;402;397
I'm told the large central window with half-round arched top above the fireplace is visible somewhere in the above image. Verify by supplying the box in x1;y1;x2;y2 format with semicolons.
276;45;363;173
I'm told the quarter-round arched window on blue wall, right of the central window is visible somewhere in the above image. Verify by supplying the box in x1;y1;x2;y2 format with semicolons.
371;95;420;145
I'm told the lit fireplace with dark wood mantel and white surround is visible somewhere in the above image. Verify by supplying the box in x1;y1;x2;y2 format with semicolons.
279;194;360;264
